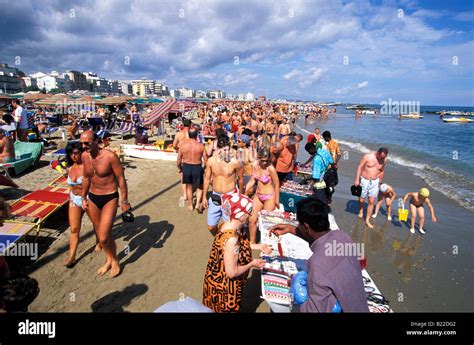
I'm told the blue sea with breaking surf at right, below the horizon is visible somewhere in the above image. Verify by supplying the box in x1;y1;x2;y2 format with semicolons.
297;105;474;212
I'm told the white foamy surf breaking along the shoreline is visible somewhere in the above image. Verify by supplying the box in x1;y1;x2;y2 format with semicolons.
297;125;474;212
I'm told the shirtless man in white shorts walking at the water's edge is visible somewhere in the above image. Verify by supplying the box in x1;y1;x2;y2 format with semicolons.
354;147;388;229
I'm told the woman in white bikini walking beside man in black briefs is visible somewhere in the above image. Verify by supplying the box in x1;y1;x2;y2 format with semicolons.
64;142;84;268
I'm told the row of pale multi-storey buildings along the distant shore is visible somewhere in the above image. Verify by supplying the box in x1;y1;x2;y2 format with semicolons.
0;63;255;101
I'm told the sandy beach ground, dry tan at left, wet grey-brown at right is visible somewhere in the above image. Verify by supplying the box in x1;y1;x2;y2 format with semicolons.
0;130;473;312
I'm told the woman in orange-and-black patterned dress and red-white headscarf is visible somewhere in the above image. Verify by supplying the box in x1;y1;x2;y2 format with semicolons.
203;193;272;313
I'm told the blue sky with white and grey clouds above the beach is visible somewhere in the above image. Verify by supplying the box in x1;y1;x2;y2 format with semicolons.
0;0;474;106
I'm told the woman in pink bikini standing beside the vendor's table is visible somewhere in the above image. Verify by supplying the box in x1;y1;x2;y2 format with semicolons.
245;147;280;243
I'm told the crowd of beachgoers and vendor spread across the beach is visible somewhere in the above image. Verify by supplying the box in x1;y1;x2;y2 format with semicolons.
0;97;436;312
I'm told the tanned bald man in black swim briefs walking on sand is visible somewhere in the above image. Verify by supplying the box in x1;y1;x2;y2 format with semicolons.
79;131;131;277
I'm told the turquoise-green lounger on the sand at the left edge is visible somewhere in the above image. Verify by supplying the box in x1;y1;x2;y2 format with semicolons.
0;141;43;177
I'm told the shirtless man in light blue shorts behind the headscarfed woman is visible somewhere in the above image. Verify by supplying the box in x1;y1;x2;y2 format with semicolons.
202;136;244;234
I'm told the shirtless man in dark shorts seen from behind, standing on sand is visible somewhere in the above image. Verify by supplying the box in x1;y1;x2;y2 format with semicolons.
177;128;205;213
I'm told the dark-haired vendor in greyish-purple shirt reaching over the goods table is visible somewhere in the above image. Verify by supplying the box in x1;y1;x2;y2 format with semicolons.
270;197;369;312
